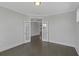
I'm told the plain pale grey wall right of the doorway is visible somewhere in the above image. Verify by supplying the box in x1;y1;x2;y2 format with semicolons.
44;11;76;46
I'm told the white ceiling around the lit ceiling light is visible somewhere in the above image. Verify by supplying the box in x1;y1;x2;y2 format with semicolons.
0;2;79;16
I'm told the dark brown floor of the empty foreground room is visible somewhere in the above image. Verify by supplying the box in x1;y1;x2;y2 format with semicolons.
0;35;78;56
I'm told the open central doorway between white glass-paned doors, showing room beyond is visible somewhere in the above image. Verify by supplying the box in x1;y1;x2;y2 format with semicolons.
31;19;42;45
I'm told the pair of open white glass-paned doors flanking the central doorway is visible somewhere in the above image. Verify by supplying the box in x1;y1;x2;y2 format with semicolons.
24;20;49;43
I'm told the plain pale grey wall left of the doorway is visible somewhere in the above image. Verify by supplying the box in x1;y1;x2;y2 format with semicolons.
0;7;27;51
